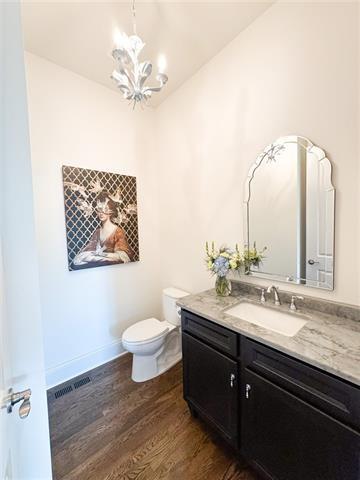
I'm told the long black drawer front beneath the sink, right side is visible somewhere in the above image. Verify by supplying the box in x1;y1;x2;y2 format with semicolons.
241;337;360;430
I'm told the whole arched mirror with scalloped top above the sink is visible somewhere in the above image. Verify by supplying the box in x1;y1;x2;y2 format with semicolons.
244;136;335;290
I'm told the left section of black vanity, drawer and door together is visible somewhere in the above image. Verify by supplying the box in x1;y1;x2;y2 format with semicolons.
182;313;239;447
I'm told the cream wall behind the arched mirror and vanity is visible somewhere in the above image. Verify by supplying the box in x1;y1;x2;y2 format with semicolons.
156;3;360;305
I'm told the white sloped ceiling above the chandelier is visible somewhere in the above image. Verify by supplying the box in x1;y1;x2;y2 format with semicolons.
22;0;271;106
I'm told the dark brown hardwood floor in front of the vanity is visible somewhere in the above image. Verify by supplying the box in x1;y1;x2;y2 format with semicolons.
48;354;258;480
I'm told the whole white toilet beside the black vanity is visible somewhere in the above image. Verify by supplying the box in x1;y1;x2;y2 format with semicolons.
122;287;189;382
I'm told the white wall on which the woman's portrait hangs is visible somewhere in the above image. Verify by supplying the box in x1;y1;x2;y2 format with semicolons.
26;54;161;385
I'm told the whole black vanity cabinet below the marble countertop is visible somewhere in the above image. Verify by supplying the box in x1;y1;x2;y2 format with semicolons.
182;309;360;480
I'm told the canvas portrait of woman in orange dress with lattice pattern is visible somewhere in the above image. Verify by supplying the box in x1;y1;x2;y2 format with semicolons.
62;166;139;270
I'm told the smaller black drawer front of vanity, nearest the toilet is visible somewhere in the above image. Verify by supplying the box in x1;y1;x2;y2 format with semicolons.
181;310;239;357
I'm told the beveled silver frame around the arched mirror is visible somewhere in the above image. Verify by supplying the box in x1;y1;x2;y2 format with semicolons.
244;135;336;290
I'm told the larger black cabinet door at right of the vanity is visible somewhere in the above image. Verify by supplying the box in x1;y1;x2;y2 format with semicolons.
242;370;360;480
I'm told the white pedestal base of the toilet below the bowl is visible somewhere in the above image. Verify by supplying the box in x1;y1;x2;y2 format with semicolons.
131;329;182;382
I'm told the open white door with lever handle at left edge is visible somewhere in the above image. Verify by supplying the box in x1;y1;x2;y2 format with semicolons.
0;2;51;480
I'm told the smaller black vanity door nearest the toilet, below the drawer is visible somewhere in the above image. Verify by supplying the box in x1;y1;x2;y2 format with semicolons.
183;333;239;446
